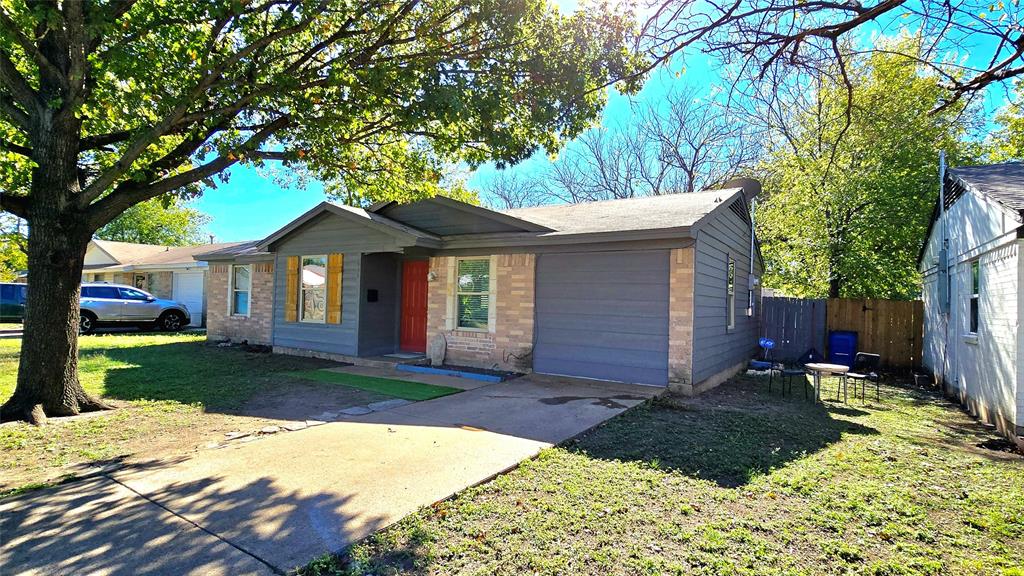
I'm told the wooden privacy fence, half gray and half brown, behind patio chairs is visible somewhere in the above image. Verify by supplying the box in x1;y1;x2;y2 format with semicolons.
761;297;925;368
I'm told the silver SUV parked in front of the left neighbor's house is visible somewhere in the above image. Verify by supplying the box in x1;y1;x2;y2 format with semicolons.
79;282;190;334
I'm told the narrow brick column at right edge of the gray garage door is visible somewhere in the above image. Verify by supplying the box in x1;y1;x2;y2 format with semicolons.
669;246;693;394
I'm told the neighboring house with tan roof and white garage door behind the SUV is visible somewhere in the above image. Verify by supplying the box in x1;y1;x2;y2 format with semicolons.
82;240;245;326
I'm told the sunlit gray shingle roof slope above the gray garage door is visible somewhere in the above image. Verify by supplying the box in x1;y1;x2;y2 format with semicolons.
504;188;742;236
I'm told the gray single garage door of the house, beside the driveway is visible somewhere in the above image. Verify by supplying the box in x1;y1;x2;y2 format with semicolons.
534;250;669;385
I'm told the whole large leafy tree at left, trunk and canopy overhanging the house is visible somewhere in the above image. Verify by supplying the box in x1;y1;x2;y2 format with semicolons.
0;0;640;421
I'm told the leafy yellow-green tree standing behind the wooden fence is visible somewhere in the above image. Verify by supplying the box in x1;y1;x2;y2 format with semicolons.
758;46;977;298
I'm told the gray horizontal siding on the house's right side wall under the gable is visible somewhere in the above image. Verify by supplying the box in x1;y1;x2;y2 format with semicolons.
693;199;761;383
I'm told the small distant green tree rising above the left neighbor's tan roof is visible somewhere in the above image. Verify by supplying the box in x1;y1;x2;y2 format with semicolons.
96;196;210;246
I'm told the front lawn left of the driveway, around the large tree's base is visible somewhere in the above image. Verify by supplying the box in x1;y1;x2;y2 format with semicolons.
0;333;331;495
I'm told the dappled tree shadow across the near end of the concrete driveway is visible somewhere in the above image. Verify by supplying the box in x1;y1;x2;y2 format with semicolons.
0;460;386;575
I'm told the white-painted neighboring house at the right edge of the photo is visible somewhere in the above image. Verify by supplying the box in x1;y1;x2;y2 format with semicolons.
919;162;1024;444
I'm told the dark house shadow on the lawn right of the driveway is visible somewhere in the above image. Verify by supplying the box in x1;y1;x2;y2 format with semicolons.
566;380;879;488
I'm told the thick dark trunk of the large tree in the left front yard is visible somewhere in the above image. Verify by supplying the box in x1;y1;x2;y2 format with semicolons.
0;125;110;424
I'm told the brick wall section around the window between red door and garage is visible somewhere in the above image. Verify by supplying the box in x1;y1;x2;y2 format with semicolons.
427;254;537;372
